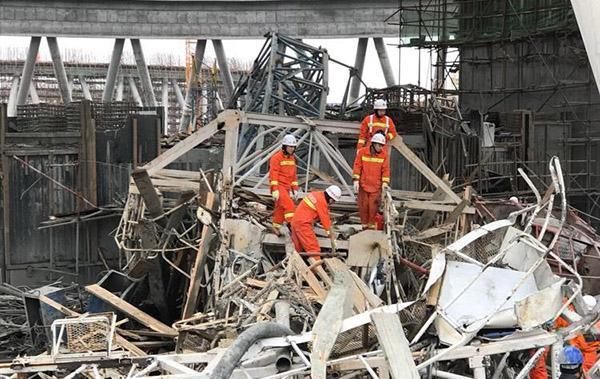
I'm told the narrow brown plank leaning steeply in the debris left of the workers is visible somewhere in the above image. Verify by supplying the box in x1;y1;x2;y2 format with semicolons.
181;192;215;319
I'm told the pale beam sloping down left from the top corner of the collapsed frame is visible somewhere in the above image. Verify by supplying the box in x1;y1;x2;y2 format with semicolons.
144;109;240;175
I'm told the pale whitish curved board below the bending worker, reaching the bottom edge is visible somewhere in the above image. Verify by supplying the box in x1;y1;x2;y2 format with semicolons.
310;272;352;379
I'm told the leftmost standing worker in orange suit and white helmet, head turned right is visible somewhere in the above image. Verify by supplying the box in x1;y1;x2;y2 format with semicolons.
269;134;298;235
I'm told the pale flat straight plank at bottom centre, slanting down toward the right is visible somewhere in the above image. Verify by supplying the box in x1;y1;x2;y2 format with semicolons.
371;313;421;379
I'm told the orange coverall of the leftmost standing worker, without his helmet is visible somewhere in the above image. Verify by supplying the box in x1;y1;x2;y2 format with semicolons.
269;150;298;228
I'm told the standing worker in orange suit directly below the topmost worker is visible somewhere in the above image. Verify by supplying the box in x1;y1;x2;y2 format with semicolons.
352;133;390;229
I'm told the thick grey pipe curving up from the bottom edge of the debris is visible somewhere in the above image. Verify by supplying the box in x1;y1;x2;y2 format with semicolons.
210;322;294;379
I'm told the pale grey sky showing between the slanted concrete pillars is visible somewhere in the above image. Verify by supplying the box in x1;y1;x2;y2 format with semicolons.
0;36;431;102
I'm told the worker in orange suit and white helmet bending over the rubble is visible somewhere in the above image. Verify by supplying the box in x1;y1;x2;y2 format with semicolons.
292;186;342;259
